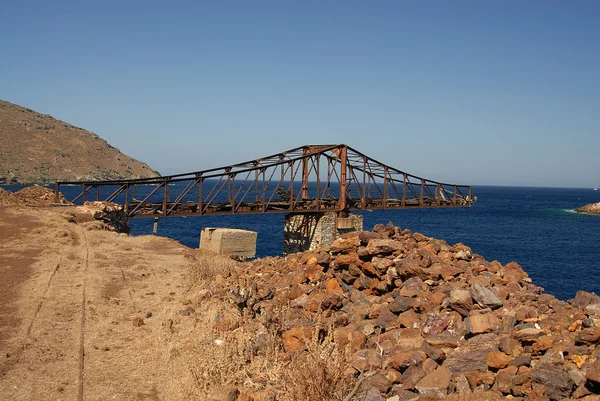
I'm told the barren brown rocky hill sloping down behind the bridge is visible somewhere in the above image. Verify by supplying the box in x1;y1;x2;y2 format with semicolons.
0;100;159;184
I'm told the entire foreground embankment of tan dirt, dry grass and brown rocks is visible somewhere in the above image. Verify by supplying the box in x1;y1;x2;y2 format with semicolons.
0;198;600;401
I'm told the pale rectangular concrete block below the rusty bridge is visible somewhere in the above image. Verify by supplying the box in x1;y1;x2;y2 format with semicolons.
200;227;258;258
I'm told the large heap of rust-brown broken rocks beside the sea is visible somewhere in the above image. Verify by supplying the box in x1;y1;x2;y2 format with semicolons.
217;223;600;401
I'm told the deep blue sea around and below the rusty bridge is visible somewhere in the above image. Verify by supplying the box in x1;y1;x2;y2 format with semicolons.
5;186;600;299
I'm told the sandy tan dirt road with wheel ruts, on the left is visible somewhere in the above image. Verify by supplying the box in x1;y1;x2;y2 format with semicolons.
0;207;204;401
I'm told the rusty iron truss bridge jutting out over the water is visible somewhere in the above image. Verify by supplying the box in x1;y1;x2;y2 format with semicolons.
56;144;475;217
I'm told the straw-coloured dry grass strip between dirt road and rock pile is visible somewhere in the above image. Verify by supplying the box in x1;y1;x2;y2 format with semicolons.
185;253;354;401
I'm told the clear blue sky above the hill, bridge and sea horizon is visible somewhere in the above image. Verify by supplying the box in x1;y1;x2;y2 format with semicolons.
0;0;600;187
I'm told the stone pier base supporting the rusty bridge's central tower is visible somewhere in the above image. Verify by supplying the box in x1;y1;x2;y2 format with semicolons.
283;212;363;254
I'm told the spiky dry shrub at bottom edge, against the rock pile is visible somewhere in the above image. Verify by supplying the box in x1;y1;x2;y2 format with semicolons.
281;322;353;401
